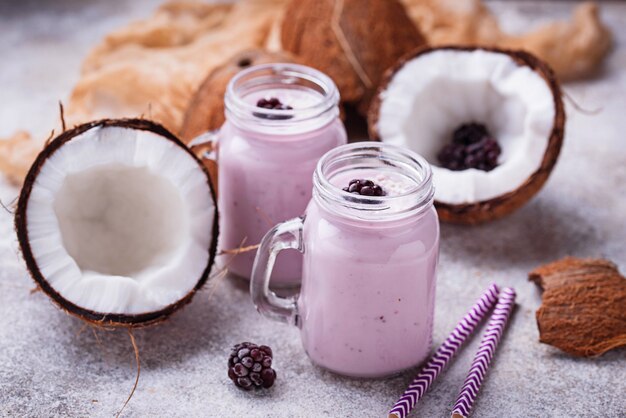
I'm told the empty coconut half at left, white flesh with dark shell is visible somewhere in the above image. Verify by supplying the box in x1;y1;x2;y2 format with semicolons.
15;119;218;326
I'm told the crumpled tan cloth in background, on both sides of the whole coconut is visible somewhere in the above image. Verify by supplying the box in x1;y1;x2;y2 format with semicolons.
0;0;611;183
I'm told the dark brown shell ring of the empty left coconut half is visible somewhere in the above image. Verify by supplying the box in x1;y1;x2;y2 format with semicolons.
15;119;219;328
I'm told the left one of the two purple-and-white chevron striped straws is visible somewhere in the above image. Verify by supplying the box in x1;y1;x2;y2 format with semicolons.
389;284;500;418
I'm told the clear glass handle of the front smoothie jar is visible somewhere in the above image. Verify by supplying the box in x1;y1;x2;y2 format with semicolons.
250;217;304;325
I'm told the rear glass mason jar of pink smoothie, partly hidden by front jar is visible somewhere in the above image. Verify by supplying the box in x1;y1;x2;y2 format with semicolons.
194;64;347;286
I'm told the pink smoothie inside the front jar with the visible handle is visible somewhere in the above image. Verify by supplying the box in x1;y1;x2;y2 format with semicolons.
298;169;439;377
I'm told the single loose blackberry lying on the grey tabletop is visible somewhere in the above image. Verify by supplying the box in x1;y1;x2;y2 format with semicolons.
228;342;276;390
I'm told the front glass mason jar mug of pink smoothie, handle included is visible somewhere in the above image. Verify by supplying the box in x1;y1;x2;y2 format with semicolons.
250;142;439;377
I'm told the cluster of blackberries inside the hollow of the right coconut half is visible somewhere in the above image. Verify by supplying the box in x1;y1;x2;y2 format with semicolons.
437;122;502;171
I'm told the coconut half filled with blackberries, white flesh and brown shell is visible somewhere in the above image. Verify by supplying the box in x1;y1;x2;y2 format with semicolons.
368;47;565;224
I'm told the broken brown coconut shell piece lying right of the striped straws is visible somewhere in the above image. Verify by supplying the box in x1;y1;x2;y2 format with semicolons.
528;257;626;357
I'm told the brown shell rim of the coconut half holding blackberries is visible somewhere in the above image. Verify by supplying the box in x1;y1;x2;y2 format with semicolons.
368;46;565;225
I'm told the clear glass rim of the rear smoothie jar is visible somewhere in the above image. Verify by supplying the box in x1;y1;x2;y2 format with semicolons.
224;63;339;129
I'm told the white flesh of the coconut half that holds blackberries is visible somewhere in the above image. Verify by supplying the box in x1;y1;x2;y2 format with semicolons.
370;48;563;222
